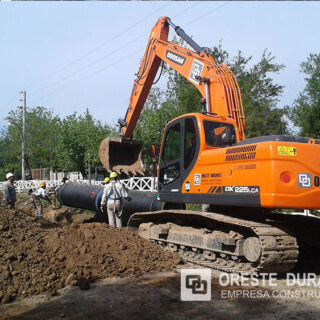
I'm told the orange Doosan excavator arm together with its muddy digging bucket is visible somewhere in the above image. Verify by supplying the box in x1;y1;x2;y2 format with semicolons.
99;17;245;173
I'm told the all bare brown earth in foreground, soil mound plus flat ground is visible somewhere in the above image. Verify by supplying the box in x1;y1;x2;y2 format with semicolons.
0;202;320;320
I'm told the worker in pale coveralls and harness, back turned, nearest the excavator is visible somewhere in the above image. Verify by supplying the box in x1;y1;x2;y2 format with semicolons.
101;172;129;228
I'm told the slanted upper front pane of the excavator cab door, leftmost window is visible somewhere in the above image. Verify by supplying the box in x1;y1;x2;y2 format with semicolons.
162;123;181;163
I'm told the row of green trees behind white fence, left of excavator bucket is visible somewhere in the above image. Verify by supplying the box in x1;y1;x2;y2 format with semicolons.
0;107;111;180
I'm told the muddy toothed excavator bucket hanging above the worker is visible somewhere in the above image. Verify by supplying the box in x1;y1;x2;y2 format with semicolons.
99;138;144;175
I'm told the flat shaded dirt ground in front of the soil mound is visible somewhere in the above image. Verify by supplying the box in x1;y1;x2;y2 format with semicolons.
0;272;320;320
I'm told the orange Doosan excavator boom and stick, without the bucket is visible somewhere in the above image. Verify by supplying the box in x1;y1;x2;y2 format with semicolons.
119;17;245;140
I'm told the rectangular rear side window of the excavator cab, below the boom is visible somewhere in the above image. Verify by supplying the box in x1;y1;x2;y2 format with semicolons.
203;120;236;147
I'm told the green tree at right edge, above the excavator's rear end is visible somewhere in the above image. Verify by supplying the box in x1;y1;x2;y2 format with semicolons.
290;53;320;138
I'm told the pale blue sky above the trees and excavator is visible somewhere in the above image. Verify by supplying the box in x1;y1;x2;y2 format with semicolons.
0;1;320;129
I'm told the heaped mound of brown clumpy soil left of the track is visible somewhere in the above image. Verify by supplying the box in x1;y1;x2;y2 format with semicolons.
0;209;180;303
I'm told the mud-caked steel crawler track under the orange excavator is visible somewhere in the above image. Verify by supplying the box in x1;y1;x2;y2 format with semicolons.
128;210;299;274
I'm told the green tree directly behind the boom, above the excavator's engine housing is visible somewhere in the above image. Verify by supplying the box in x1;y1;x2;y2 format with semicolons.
211;43;288;138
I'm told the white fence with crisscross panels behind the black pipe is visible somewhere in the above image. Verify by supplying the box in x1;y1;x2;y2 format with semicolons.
0;177;156;193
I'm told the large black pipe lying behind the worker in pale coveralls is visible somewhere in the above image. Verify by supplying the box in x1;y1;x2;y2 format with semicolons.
56;182;164;214
